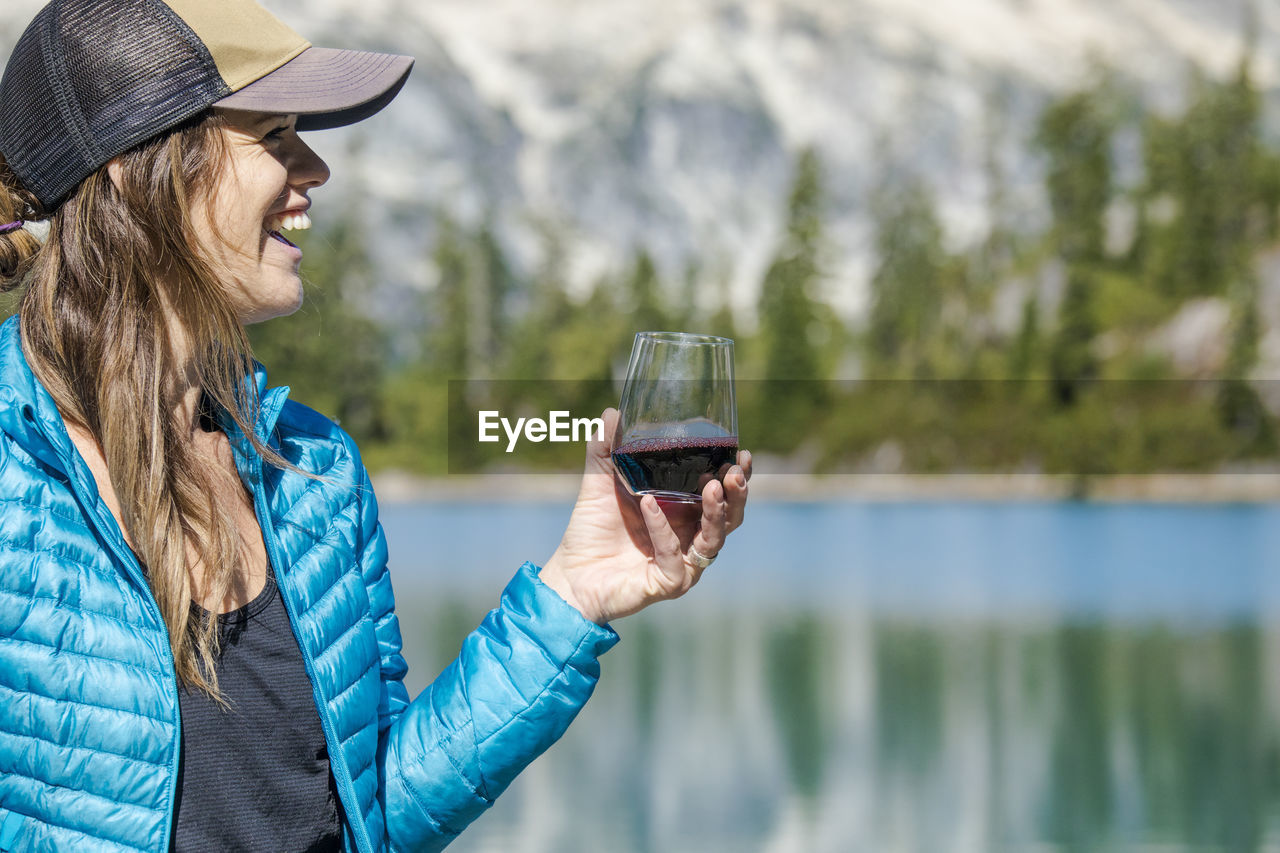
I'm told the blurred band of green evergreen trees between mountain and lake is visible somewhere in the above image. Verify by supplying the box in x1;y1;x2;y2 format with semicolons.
2;61;1280;478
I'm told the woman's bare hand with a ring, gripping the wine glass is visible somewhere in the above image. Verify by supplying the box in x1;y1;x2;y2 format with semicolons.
541;409;751;625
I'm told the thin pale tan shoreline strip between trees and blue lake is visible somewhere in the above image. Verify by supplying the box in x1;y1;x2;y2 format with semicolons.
371;467;1280;505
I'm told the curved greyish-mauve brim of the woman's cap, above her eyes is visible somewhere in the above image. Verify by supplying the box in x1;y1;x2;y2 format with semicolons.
214;47;413;131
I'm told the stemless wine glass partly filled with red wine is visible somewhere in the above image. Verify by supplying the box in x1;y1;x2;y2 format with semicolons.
613;332;737;503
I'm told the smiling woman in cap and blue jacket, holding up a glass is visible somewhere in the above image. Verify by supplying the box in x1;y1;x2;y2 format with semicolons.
0;0;749;852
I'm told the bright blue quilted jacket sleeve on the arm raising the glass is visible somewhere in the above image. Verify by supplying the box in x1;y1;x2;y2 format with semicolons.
362;466;618;852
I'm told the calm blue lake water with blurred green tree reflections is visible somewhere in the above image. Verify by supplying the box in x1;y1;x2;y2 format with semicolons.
384;503;1280;853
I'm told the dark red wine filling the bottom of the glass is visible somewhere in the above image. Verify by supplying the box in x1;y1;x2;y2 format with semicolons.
613;435;737;494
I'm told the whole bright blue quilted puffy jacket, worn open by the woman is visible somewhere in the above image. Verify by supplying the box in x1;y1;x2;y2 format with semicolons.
0;319;617;853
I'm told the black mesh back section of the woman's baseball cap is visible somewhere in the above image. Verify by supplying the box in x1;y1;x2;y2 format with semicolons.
0;0;230;210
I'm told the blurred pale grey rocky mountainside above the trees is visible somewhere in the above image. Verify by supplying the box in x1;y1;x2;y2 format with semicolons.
0;0;1280;325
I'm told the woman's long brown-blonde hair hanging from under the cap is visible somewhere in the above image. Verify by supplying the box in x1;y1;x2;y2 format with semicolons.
0;111;283;698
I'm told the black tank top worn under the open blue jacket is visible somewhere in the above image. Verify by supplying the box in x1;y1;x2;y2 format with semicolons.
173;575;342;853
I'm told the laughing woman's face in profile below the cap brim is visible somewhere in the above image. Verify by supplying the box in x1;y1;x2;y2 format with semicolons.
201;110;329;325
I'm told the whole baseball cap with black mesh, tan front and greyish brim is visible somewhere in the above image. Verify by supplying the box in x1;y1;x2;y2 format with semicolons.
0;0;413;211
